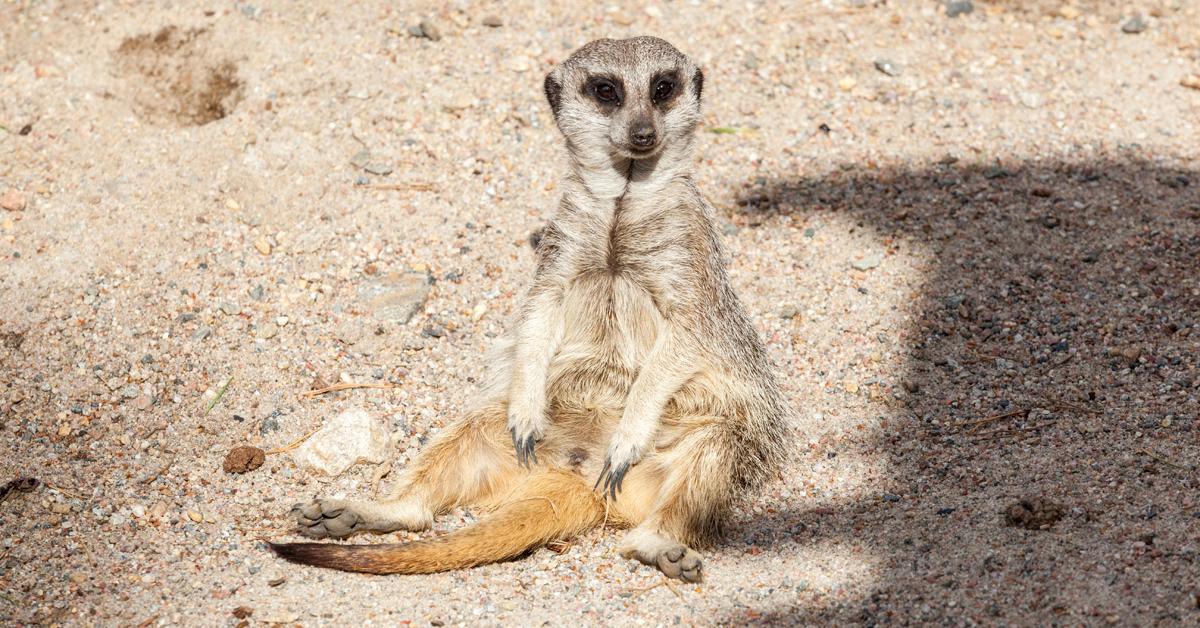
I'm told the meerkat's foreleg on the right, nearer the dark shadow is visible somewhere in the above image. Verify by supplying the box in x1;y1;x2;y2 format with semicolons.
596;329;695;498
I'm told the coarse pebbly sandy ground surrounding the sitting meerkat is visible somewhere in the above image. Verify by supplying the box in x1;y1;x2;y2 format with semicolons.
0;0;1200;626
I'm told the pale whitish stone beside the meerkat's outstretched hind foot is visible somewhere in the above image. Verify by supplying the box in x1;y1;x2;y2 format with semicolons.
292;408;390;476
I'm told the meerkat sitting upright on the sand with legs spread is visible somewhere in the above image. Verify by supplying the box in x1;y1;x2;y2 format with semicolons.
274;37;791;581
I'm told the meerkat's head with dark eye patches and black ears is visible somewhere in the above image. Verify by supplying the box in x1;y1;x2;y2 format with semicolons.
545;37;704;161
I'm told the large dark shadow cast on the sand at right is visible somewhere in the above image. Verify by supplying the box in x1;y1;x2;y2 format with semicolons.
715;157;1200;626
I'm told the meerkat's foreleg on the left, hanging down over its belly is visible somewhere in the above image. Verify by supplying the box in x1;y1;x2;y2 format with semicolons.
508;291;563;467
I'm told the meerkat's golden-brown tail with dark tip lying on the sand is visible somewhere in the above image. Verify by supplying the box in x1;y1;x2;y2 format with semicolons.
271;469;604;574
